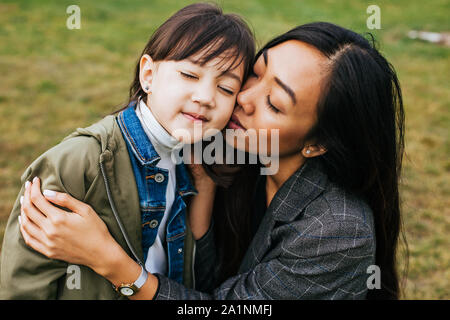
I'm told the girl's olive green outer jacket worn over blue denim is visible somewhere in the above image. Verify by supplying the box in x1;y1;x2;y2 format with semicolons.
0;116;195;299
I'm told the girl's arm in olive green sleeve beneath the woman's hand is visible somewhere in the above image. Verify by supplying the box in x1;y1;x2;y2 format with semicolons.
0;136;100;300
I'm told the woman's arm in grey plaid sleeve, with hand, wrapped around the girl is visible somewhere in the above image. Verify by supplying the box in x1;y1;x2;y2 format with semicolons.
21;178;374;299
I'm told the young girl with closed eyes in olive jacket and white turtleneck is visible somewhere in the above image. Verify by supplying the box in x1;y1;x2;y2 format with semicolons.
0;4;254;299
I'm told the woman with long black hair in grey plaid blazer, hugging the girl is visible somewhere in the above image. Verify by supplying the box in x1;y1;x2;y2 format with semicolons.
17;23;404;299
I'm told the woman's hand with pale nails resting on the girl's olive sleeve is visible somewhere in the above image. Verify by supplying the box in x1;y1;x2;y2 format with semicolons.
19;178;118;273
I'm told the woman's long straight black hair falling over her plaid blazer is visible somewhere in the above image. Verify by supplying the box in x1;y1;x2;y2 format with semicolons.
215;22;407;299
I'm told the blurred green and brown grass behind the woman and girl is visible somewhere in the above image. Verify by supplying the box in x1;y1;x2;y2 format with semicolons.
0;0;450;299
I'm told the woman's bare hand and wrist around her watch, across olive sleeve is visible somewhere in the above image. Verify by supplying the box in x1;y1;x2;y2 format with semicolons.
19;178;158;299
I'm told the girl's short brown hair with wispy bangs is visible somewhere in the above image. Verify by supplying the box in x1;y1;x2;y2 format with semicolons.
116;3;255;112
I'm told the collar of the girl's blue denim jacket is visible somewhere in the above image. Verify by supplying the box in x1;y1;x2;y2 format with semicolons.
117;101;197;196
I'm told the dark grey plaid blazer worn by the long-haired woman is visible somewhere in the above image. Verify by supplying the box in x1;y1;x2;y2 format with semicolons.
155;160;375;300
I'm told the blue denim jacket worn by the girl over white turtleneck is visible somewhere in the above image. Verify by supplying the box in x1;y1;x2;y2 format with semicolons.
117;103;197;283
